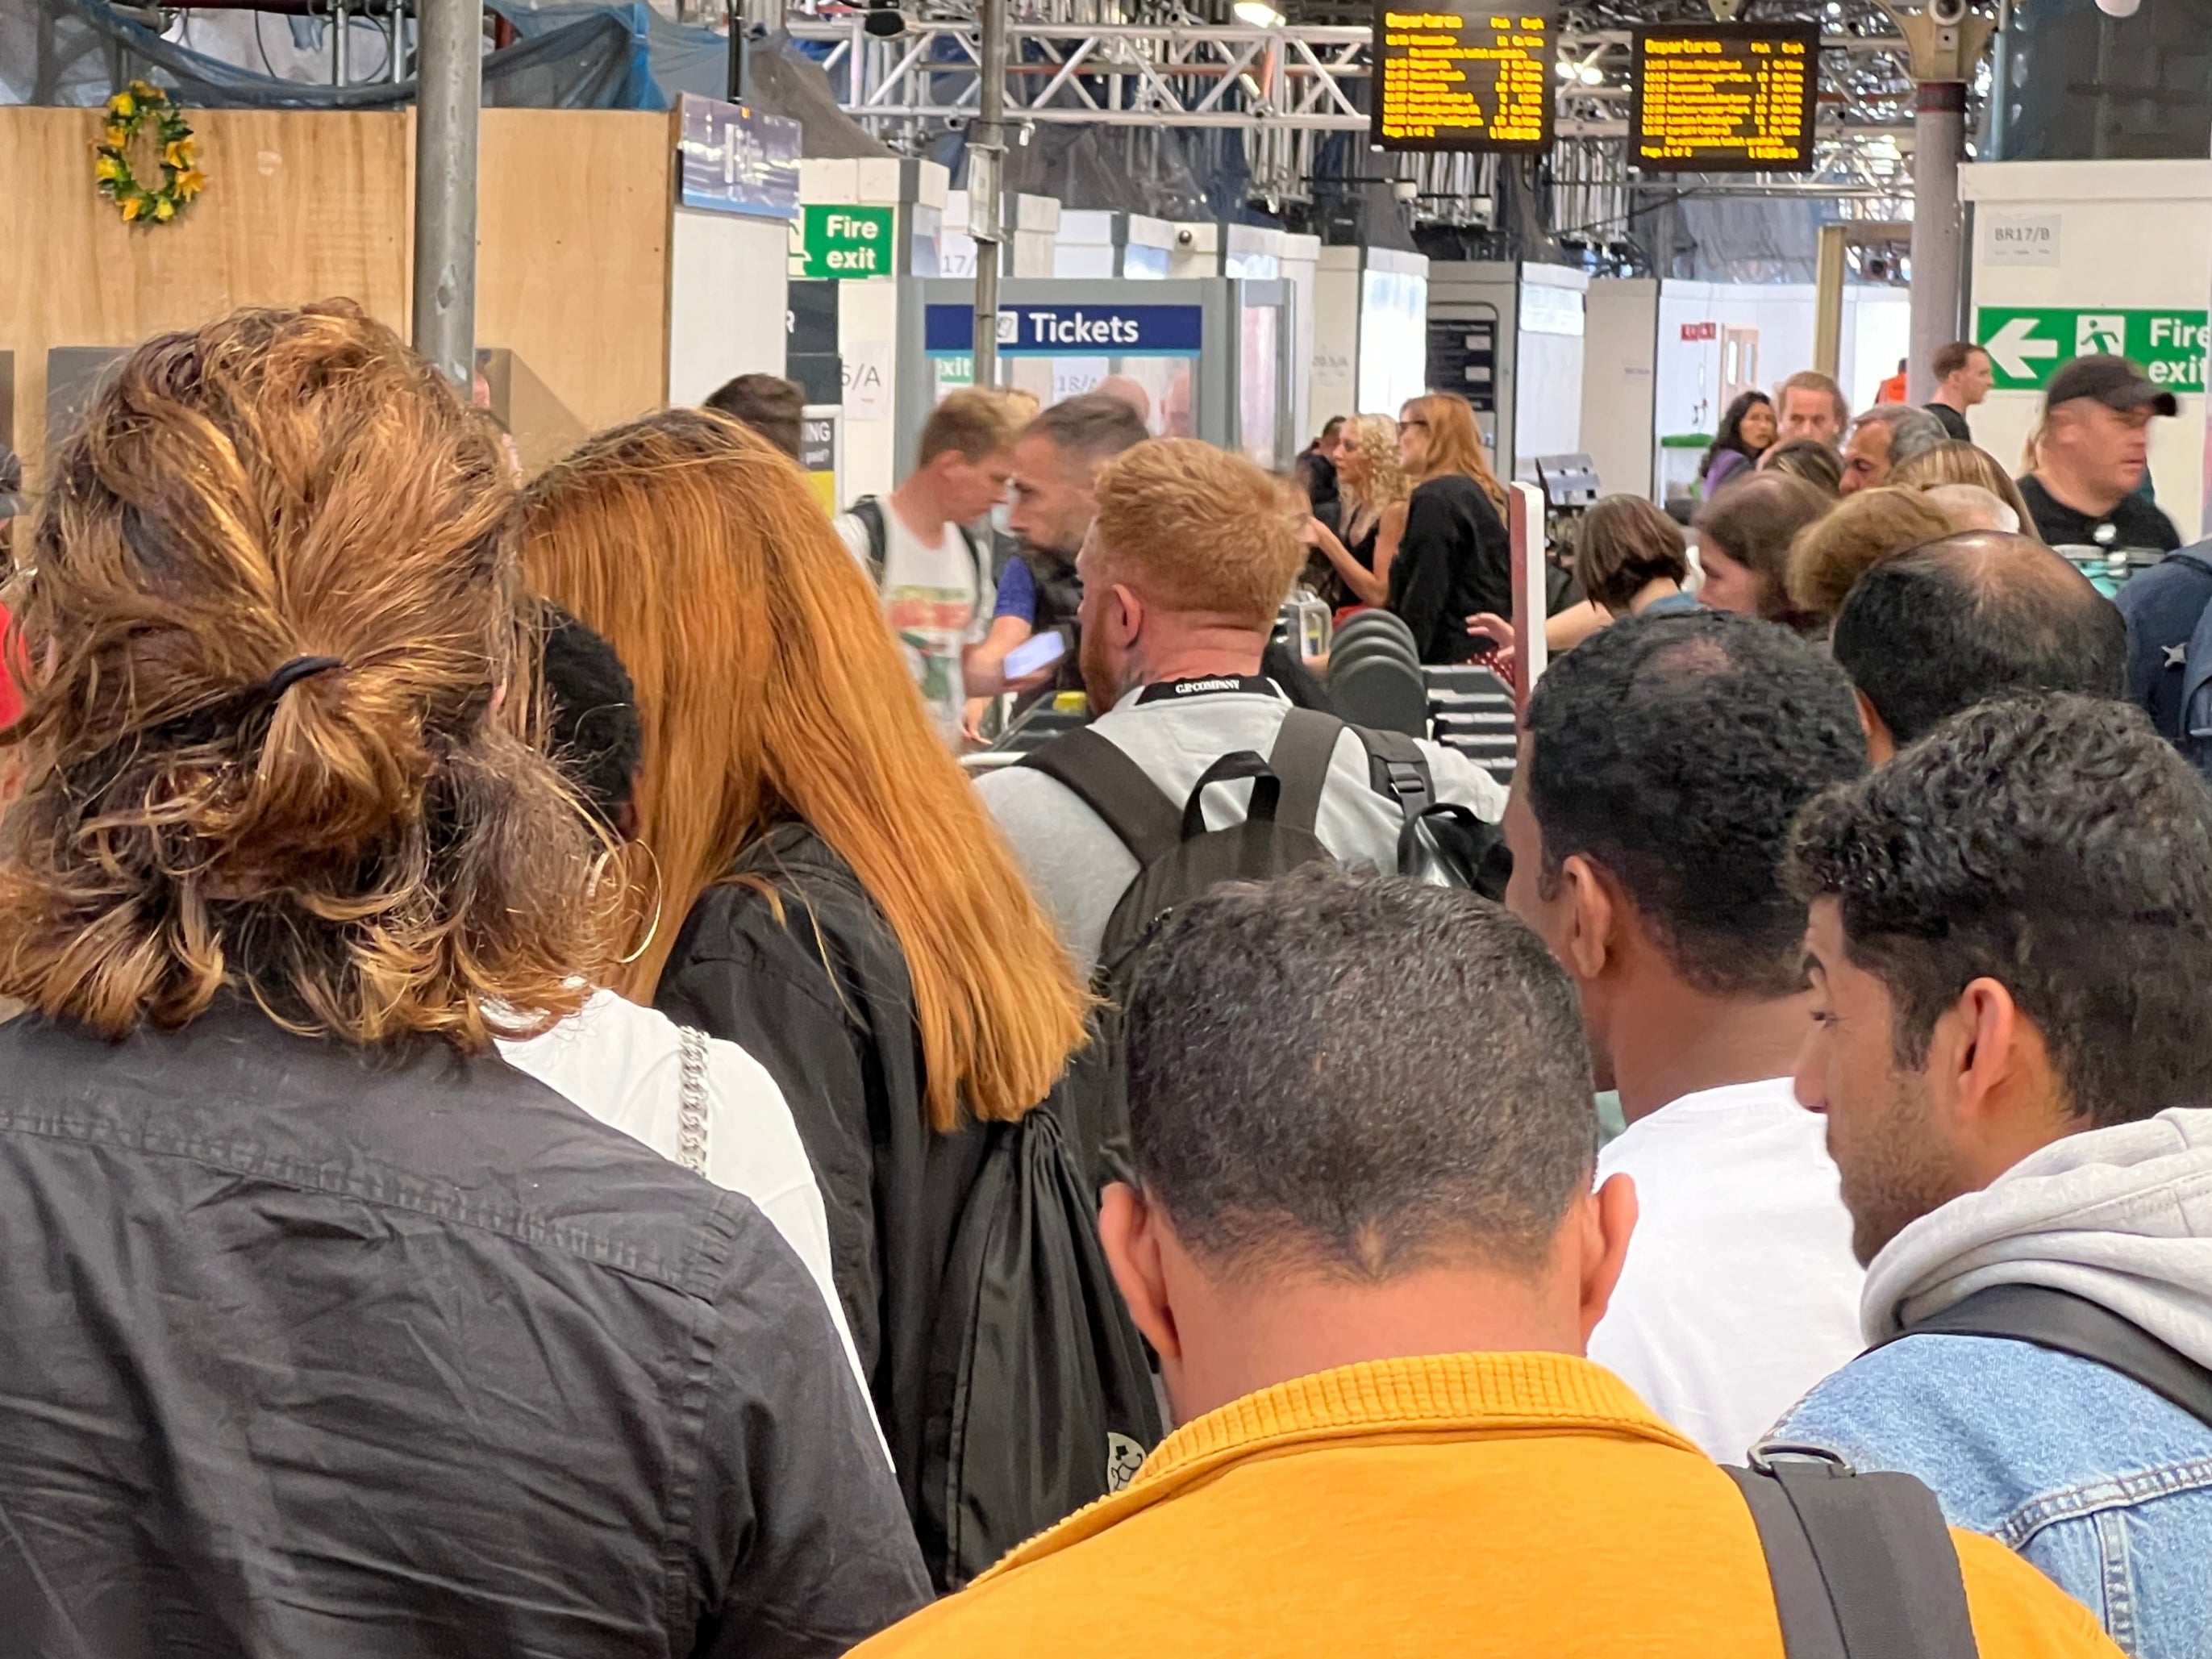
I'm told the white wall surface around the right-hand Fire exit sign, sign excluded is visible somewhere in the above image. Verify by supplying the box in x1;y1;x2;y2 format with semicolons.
1960;161;2212;540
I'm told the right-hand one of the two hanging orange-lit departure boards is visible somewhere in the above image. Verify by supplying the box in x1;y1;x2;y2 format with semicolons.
1628;22;1820;173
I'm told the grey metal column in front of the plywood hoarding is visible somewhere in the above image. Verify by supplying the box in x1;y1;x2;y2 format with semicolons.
414;0;485;394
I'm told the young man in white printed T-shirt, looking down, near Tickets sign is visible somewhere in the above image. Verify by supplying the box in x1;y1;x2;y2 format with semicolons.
836;387;1015;748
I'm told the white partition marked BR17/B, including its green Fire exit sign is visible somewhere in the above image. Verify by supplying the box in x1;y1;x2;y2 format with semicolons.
1960;161;2212;540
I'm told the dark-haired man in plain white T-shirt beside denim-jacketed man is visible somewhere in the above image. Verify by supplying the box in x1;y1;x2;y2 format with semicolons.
1506;611;1867;1462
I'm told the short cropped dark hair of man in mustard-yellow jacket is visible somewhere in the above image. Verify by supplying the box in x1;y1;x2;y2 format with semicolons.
1128;865;1597;1283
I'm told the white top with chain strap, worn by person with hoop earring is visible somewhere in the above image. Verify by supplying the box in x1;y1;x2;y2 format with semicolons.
500;991;867;1424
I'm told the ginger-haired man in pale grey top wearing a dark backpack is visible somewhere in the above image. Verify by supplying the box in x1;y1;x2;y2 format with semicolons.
977;438;1504;976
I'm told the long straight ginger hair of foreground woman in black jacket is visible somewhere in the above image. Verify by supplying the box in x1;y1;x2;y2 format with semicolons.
524;409;1086;1131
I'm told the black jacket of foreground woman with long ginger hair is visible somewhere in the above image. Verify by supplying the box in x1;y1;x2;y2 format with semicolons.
657;823;998;1565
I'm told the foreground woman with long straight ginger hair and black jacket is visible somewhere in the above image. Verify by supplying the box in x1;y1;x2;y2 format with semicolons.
524;409;1086;1582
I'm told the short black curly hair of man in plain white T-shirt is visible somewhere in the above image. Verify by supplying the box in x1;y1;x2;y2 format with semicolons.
1527;611;1867;995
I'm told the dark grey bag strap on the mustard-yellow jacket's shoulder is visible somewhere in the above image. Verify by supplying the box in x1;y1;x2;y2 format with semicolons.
1727;1444;1980;1659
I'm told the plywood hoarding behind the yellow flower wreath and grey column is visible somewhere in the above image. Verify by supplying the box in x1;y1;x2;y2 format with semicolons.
0;106;675;482
